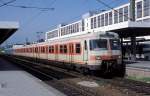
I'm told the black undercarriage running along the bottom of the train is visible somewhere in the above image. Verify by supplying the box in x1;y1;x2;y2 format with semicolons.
8;56;125;77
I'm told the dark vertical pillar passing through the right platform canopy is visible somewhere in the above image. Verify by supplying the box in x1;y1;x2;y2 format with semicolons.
130;0;136;61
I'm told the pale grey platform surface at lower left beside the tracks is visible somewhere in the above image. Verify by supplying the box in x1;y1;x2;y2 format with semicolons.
0;58;65;96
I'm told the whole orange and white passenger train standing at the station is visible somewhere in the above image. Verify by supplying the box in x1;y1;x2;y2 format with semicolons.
13;32;125;76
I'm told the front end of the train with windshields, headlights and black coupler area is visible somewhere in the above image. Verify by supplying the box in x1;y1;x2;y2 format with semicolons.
89;32;125;76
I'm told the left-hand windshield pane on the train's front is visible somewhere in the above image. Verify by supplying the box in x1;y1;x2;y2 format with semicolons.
90;39;108;51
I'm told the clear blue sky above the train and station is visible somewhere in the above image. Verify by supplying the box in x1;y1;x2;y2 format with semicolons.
0;0;128;44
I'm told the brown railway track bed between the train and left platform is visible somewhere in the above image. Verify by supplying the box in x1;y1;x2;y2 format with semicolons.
2;54;150;96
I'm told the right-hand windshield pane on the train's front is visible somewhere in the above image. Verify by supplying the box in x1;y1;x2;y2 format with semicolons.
110;39;121;50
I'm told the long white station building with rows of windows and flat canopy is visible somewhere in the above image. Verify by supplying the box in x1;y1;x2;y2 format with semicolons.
45;0;150;60
